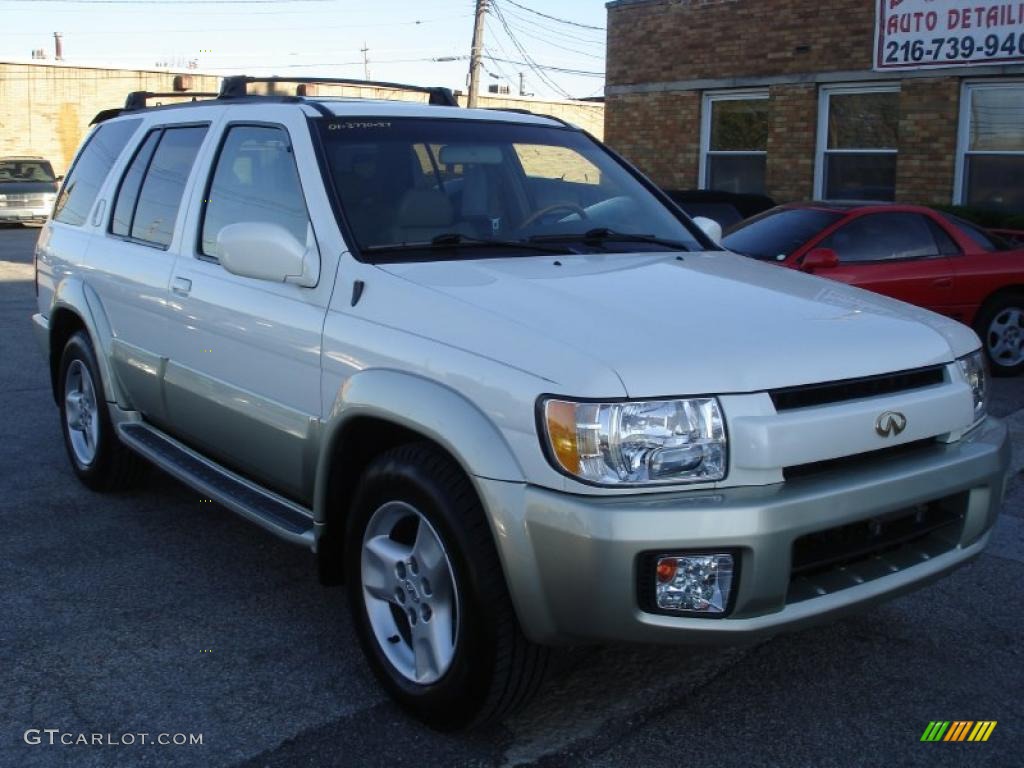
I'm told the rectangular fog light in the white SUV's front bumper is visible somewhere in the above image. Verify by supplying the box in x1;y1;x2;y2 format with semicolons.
654;555;732;613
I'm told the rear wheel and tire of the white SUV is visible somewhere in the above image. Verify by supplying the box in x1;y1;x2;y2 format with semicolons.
57;331;144;492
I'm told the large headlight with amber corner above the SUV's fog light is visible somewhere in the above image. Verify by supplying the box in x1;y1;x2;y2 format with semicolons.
542;397;727;485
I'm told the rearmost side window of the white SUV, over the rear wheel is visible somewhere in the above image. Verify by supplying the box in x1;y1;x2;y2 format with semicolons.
53;120;142;226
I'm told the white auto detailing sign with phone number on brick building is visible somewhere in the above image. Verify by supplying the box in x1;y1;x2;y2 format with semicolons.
874;0;1024;70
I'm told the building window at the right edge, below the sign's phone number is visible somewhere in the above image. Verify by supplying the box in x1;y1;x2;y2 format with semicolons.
955;82;1024;213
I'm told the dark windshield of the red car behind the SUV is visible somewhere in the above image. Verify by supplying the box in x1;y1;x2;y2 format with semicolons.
722;208;843;261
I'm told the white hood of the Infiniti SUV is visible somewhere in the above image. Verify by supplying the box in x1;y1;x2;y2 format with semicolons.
380;252;979;397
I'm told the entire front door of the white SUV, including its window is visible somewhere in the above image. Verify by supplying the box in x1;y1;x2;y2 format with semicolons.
164;117;333;502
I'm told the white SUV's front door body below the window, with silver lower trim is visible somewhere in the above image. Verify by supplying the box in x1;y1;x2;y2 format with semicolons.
164;268;326;498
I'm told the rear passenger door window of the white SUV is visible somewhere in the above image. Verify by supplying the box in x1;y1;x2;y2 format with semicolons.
126;126;207;248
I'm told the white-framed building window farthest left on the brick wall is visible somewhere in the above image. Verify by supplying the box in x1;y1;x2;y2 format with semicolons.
700;91;769;195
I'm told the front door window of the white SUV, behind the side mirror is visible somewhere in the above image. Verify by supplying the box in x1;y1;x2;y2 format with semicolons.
201;125;309;258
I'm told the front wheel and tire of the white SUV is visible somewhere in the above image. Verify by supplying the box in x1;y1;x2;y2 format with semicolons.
344;443;548;730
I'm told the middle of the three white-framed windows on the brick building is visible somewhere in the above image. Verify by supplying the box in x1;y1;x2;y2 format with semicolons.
814;85;899;200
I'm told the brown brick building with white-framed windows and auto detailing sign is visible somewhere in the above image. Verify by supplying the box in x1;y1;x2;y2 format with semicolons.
605;0;1024;213
